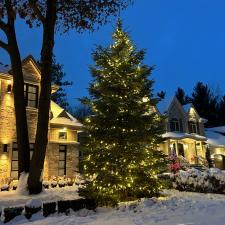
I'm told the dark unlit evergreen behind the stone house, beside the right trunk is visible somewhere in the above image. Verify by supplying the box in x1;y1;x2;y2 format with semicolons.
51;56;73;109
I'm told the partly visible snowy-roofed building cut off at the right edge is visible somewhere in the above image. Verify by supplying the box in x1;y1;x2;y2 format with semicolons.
205;126;225;170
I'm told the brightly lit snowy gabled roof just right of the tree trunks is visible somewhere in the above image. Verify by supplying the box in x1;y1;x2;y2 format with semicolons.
50;101;83;128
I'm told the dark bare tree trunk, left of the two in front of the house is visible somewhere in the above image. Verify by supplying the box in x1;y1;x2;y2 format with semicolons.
6;11;30;175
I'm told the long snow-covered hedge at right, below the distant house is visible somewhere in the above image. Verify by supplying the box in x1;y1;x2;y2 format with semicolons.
171;168;225;193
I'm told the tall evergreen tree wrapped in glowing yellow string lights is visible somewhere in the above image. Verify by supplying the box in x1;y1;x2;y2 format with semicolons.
80;21;165;204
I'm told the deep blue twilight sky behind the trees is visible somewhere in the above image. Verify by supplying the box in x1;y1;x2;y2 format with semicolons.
0;0;225;104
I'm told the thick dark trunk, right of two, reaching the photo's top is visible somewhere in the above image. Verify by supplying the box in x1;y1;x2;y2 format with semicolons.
28;0;56;194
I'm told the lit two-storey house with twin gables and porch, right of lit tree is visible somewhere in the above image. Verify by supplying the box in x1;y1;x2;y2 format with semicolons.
157;96;207;164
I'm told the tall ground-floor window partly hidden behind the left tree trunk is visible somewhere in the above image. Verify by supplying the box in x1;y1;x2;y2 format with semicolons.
11;143;34;179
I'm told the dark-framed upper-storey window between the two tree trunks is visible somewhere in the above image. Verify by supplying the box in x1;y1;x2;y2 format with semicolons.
24;83;38;108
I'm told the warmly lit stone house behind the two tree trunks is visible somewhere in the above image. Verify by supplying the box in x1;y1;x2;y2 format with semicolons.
0;56;82;183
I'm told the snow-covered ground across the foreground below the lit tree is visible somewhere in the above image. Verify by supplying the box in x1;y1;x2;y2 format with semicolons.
3;190;225;225
